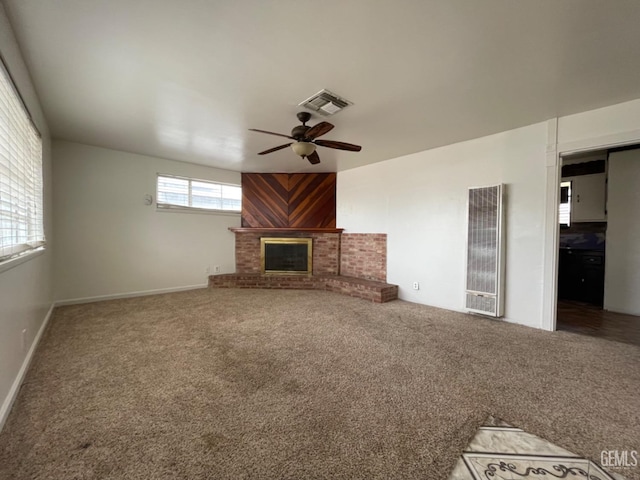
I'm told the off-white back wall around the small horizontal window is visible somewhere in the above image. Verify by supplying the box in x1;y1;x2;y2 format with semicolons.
53;141;240;301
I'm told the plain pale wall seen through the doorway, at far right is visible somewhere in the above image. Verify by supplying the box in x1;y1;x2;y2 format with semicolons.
604;150;640;315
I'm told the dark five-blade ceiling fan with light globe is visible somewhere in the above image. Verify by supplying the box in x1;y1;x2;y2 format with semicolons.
249;112;362;165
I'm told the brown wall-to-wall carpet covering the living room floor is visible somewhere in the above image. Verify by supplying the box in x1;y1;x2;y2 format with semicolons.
0;289;640;480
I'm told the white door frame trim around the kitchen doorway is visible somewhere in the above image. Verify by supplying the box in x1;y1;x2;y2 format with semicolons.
540;118;640;331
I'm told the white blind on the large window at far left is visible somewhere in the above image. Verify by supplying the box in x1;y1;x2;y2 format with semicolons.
0;62;45;262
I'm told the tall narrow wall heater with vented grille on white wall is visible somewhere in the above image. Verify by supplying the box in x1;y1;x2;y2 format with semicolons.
465;185;504;317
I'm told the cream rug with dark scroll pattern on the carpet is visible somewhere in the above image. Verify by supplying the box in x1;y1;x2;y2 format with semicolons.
449;417;625;480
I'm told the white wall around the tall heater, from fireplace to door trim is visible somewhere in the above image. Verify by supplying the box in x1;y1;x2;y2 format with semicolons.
337;123;547;328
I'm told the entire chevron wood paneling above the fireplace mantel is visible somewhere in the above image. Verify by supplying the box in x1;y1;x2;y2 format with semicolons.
242;173;336;228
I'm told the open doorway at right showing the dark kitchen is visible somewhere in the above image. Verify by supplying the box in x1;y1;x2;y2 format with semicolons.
556;145;640;345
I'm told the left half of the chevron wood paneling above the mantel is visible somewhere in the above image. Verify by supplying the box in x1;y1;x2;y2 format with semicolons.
241;173;289;228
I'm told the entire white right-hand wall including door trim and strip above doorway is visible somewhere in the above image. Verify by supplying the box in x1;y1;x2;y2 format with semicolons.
337;100;640;330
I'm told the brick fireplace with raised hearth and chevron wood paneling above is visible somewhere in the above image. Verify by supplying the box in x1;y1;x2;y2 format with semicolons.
209;173;398;302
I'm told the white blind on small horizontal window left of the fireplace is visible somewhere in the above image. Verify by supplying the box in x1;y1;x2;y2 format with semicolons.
157;175;242;212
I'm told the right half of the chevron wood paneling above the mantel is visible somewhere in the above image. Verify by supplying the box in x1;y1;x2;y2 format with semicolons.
289;173;336;228
